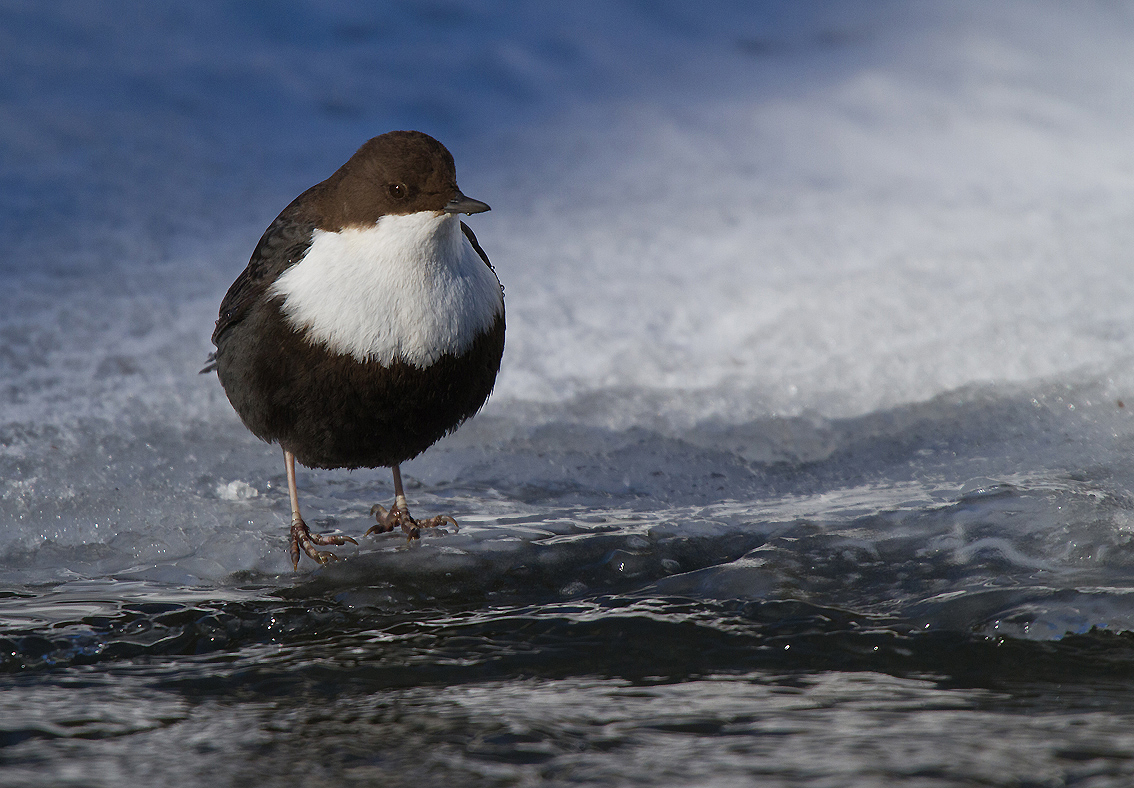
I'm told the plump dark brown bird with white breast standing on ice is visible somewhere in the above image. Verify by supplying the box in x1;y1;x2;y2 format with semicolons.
202;130;505;570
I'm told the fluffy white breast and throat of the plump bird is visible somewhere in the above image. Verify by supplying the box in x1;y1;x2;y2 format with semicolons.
269;211;503;368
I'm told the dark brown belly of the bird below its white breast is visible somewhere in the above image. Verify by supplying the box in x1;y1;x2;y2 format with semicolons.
217;304;505;468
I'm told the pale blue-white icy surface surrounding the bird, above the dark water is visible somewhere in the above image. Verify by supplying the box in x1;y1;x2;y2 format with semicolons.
0;0;1134;637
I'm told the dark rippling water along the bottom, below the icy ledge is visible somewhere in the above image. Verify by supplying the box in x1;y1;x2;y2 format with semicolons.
0;582;1134;786
